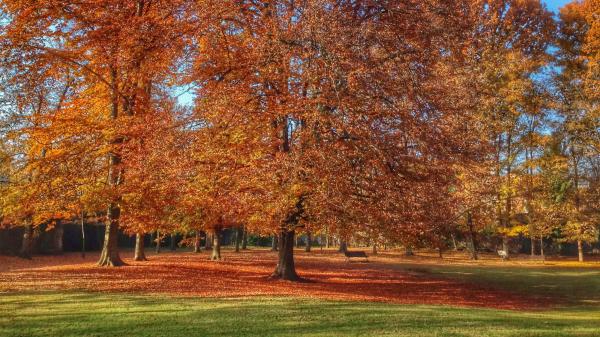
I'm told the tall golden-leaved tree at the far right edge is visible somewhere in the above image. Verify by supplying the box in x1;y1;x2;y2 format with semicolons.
555;1;600;261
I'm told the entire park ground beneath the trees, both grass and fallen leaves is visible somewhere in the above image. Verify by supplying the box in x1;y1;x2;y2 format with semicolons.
0;248;600;337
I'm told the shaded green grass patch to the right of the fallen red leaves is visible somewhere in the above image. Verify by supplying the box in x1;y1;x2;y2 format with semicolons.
400;264;600;306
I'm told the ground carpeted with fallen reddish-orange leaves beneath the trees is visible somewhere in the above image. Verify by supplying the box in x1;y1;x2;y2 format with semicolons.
0;250;561;310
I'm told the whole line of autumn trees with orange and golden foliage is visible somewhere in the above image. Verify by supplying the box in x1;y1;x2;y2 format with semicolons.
0;0;600;279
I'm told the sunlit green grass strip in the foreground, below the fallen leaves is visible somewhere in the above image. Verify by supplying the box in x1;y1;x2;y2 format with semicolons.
0;293;600;337
